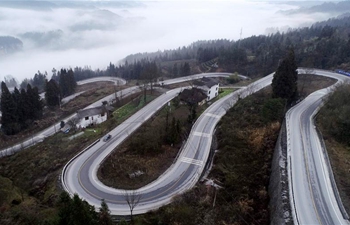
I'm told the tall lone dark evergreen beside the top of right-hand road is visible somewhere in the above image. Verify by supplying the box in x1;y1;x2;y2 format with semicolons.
272;49;298;102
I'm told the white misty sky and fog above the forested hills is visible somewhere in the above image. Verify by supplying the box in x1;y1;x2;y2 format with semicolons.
0;0;342;81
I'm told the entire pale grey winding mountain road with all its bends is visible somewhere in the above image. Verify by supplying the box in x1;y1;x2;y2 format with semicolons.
0;69;349;225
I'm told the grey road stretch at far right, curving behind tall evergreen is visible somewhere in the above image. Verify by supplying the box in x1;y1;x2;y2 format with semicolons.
286;69;350;225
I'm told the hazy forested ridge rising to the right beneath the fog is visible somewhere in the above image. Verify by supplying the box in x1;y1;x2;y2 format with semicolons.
119;14;350;79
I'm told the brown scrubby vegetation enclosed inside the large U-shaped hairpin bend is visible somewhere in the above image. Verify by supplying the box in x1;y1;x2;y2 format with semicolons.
98;85;234;189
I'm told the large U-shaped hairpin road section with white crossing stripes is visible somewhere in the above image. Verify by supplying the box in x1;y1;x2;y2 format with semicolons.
61;75;272;215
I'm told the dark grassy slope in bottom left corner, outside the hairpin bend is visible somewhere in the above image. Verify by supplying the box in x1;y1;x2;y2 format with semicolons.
0;89;157;225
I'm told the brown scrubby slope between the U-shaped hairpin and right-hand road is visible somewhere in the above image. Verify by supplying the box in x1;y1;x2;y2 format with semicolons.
136;72;335;225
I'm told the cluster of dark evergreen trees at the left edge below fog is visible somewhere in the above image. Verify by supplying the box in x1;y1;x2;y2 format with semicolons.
0;69;77;135
